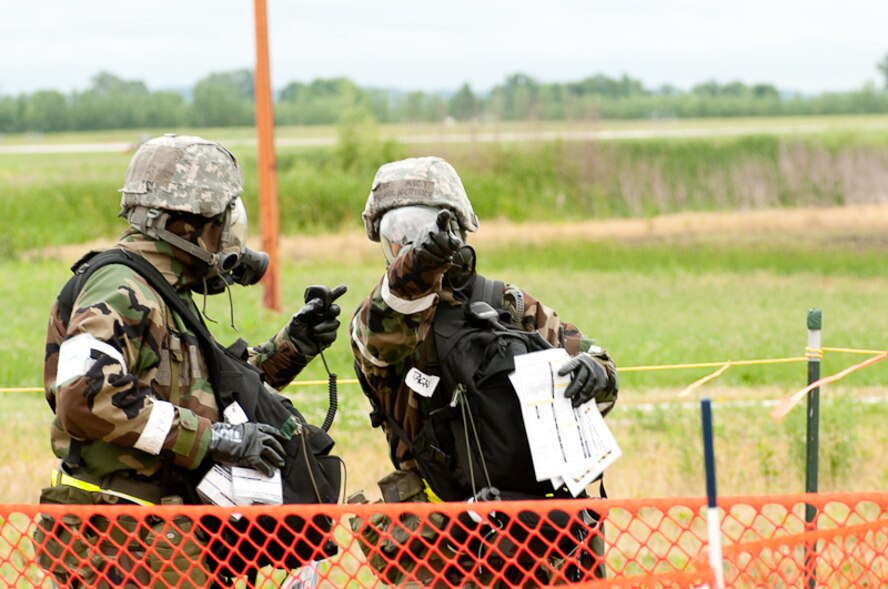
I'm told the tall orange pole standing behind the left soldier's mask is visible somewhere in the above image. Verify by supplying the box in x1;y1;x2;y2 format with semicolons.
255;0;281;311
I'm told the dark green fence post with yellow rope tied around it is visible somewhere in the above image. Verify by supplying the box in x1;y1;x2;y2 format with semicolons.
805;309;823;589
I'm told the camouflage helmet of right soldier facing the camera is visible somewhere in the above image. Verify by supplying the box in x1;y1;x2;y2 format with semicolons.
363;157;478;241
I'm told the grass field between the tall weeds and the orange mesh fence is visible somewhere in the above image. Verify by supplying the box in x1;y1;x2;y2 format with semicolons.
0;209;888;501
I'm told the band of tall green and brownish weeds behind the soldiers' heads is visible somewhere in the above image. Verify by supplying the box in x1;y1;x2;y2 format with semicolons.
0;129;888;258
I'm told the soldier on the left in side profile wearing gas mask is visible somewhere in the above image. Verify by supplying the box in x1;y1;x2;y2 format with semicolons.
41;135;339;586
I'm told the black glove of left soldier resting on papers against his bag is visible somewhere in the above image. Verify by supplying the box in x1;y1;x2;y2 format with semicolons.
209;421;286;476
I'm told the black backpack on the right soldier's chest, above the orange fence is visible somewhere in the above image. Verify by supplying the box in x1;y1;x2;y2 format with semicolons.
357;276;553;501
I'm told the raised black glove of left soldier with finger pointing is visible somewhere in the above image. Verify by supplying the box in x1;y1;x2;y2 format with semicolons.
287;284;348;356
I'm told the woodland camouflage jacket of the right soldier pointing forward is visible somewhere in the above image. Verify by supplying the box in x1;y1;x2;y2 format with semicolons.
349;250;617;469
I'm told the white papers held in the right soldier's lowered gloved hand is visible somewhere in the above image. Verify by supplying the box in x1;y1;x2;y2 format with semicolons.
510;348;622;497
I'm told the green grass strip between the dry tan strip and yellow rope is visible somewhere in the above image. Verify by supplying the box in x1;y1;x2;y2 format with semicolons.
10;232;888;389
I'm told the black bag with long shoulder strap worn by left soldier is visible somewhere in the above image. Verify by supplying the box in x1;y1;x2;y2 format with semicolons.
58;249;342;577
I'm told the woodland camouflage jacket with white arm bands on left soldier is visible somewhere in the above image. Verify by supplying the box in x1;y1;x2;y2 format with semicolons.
43;232;309;494
